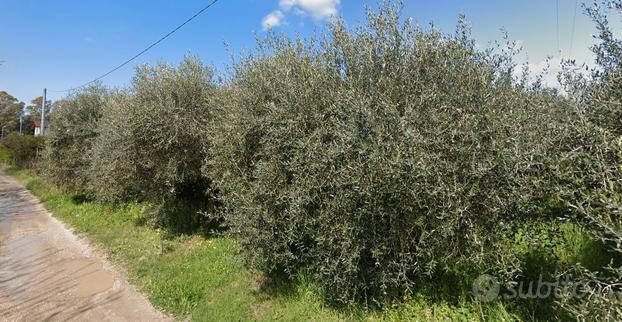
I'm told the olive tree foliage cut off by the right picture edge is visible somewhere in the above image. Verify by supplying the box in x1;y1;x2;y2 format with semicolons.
561;0;622;321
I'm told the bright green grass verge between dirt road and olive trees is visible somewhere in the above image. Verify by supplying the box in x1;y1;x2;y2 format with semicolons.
7;169;608;321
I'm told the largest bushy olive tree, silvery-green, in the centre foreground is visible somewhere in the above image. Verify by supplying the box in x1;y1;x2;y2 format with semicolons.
204;5;604;304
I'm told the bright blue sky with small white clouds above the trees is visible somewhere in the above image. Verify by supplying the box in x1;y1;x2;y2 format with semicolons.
0;0;619;102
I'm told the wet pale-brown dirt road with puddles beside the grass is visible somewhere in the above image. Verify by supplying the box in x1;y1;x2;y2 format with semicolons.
0;172;167;321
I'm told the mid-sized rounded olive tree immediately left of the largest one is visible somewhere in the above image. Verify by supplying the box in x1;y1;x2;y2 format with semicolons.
90;57;216;230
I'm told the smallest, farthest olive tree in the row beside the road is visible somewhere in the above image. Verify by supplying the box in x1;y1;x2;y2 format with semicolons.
43;85;109;193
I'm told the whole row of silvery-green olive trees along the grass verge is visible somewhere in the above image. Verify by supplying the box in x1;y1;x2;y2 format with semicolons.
47;1;620;314
